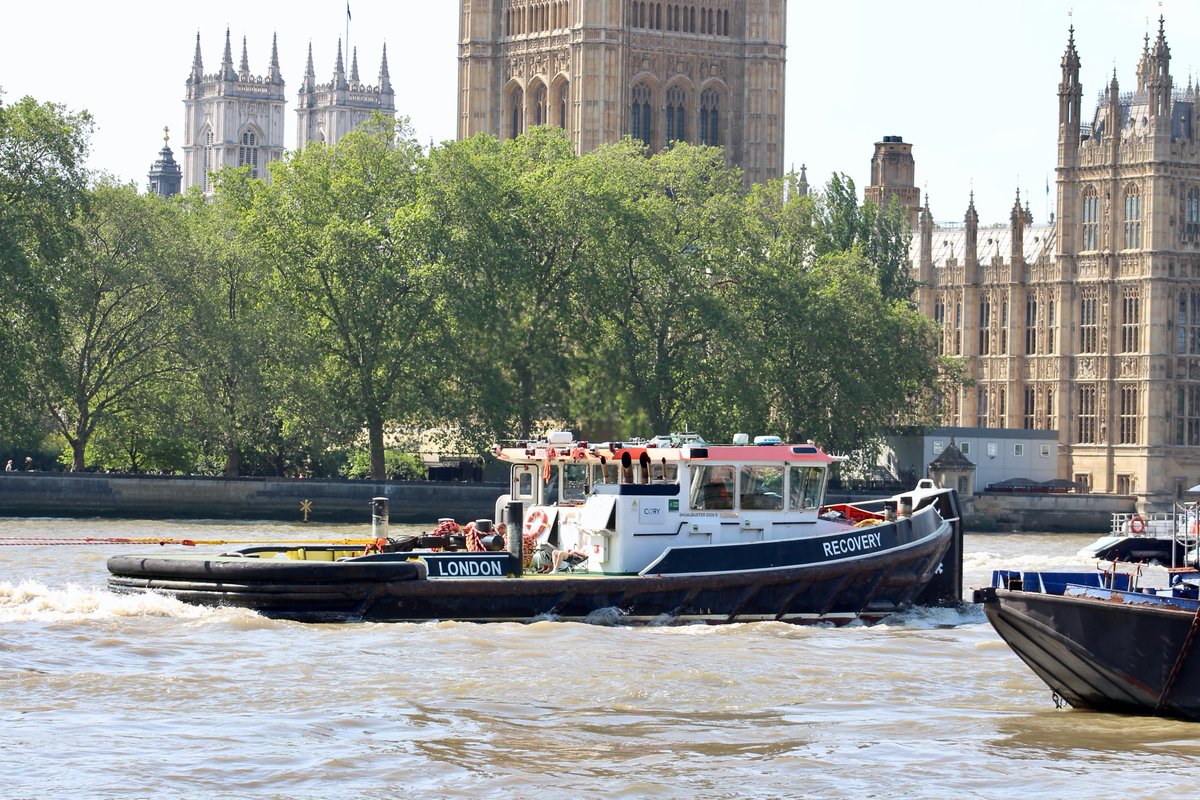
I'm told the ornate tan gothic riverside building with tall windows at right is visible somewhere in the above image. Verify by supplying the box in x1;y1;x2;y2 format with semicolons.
888;19;1200;510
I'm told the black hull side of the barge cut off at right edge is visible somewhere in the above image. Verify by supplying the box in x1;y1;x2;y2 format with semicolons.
977;589;1200;720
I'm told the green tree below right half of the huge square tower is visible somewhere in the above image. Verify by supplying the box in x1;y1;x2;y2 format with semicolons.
576;139;743;434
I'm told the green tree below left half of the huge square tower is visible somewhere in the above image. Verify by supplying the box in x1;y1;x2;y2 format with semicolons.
428;128;595;445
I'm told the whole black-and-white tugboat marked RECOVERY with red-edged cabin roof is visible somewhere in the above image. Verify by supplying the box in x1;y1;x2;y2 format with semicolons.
108;432;962;624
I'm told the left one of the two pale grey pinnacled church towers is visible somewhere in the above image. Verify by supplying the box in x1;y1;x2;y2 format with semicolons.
184;29;287;193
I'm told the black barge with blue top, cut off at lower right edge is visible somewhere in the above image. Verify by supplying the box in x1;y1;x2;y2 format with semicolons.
973;564;1200;720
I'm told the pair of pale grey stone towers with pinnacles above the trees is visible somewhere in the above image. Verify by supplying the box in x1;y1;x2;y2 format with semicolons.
182;30;396;193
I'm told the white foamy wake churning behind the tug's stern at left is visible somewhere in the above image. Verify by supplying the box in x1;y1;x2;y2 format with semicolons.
0;581;253;622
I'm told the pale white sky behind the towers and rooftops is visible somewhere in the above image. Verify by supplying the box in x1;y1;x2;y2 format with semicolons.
0;0;1200;224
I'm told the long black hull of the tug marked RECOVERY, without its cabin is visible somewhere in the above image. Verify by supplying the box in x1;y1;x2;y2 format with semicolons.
108;521;959;624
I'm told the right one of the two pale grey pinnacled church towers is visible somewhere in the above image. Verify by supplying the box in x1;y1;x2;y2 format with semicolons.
296;40;396;150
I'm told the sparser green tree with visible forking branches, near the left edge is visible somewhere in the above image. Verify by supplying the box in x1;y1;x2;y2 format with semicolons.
32;181;187;470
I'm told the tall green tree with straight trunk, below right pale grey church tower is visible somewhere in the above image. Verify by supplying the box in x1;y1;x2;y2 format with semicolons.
248;116;442;479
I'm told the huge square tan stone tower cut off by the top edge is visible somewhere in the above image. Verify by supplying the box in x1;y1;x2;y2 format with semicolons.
458;0;787;184
